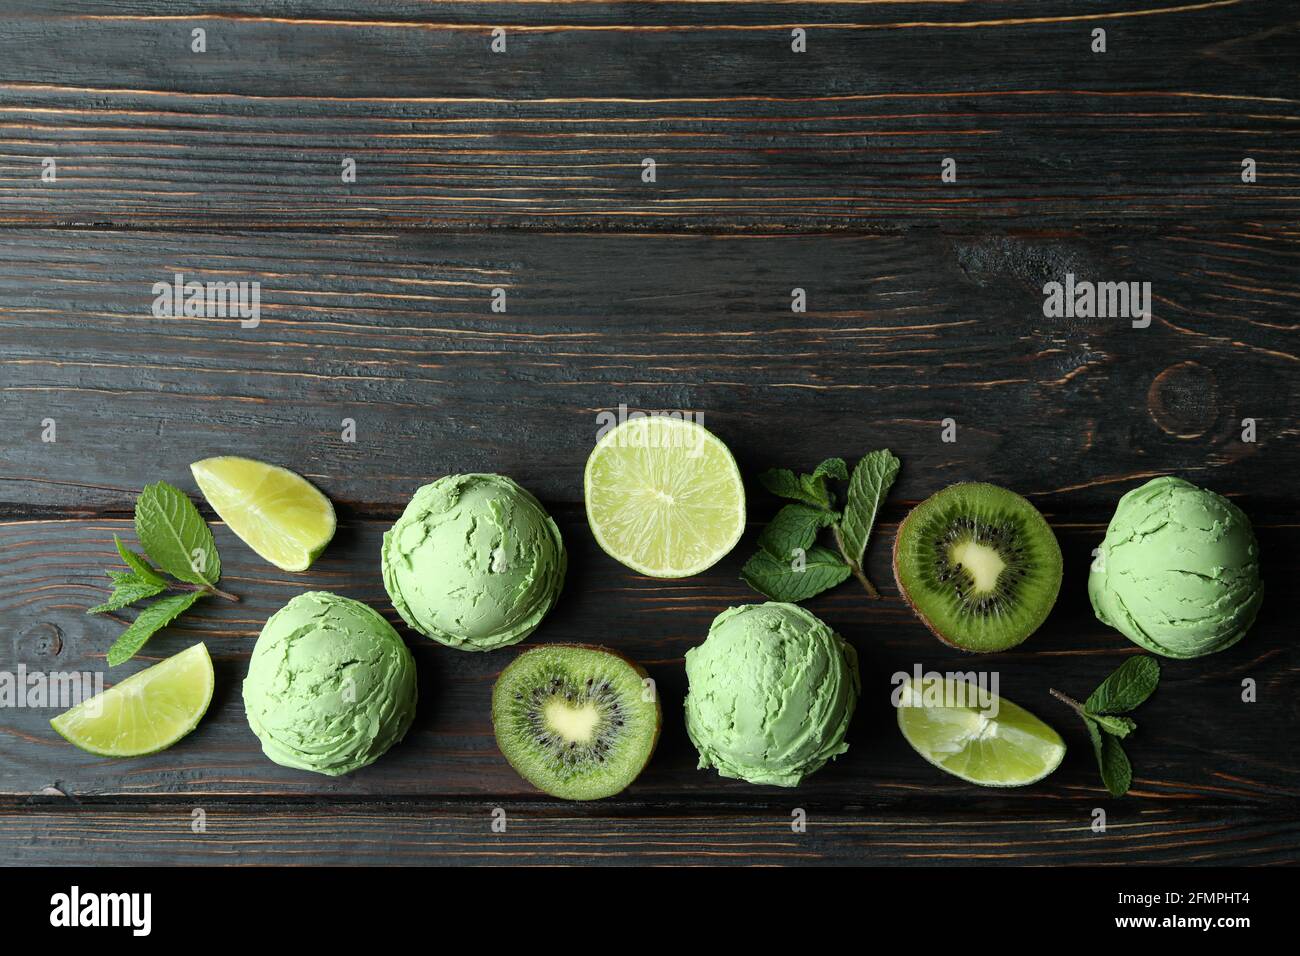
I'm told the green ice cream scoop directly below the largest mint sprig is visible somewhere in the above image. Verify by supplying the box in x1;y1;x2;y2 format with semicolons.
686;604;861;787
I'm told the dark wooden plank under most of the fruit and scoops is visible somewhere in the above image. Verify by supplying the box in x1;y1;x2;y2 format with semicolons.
0;507;1300;819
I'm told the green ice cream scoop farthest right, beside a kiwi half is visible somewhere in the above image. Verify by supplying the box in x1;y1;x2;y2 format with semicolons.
1088;477;1264;657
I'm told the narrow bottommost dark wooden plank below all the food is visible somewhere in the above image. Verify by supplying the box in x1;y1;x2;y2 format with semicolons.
0;803;1300;866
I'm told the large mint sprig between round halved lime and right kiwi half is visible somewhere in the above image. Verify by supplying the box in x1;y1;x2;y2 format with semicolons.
740;450;900;602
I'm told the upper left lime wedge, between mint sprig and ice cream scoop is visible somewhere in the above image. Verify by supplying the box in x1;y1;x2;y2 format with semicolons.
190;455;335;571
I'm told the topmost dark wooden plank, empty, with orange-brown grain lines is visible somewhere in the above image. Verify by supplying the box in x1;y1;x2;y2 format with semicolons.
0;0;1300;232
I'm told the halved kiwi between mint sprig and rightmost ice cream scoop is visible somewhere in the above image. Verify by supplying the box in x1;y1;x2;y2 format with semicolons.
894;483;1061;653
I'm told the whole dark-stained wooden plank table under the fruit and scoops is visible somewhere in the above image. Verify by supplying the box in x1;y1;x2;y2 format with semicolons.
0;0;1300;865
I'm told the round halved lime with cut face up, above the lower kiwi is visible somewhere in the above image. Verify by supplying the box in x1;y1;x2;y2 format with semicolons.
582;415;745;578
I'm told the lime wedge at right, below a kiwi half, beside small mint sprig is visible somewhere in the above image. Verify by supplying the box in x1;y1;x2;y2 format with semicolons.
898;676;1065;787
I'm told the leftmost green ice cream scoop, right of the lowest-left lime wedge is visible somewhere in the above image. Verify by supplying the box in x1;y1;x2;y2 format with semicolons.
243;591;416;777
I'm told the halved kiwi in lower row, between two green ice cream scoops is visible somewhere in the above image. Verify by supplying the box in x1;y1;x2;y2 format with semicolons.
491;644;662;800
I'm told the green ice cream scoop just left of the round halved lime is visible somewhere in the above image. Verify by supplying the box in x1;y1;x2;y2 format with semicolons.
384;475;567;650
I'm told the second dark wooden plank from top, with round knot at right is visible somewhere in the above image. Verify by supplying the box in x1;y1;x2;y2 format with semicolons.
0;224;1300;520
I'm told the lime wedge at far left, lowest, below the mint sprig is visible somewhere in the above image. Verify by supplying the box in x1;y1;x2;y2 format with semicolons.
49;644;212;757
